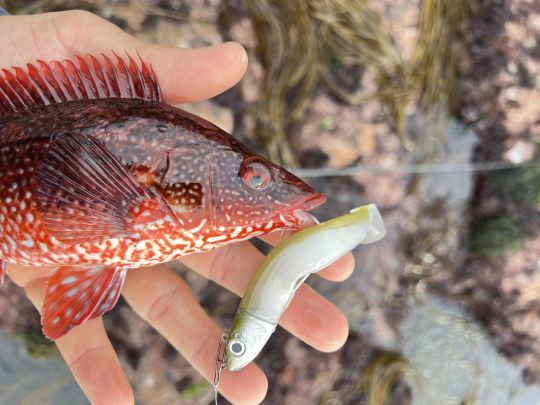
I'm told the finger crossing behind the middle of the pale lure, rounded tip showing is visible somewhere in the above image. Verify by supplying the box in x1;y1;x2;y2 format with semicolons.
181;243;349;352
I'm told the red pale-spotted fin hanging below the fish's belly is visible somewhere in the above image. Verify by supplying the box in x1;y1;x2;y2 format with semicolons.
41;266;126;340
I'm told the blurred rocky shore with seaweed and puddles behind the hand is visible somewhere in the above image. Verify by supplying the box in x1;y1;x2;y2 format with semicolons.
0;0;540;405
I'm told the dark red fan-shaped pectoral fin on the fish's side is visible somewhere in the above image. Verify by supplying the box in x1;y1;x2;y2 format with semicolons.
35;134;173;245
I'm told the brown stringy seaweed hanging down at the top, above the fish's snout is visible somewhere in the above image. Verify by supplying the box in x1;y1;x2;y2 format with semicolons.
233;0;468;166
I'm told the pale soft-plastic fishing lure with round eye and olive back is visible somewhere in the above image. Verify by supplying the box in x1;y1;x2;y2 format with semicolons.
226;204;386;371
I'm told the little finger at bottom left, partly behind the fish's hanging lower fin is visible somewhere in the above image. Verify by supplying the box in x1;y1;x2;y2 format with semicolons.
25;278;134;405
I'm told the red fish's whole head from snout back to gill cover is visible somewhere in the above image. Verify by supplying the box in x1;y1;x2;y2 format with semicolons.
143;107;326;238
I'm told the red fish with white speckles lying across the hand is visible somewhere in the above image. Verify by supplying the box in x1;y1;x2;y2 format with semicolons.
0;55;325;339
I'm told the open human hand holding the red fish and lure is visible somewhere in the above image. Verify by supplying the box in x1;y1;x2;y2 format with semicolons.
0;11;354;404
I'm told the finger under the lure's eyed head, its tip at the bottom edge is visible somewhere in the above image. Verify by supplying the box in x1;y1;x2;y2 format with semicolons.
123;265;268;404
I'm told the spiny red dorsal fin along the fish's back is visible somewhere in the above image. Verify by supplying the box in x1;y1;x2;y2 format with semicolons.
0;52;162;115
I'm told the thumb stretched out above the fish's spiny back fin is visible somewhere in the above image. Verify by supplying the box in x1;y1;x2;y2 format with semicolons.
54;13;247;104
